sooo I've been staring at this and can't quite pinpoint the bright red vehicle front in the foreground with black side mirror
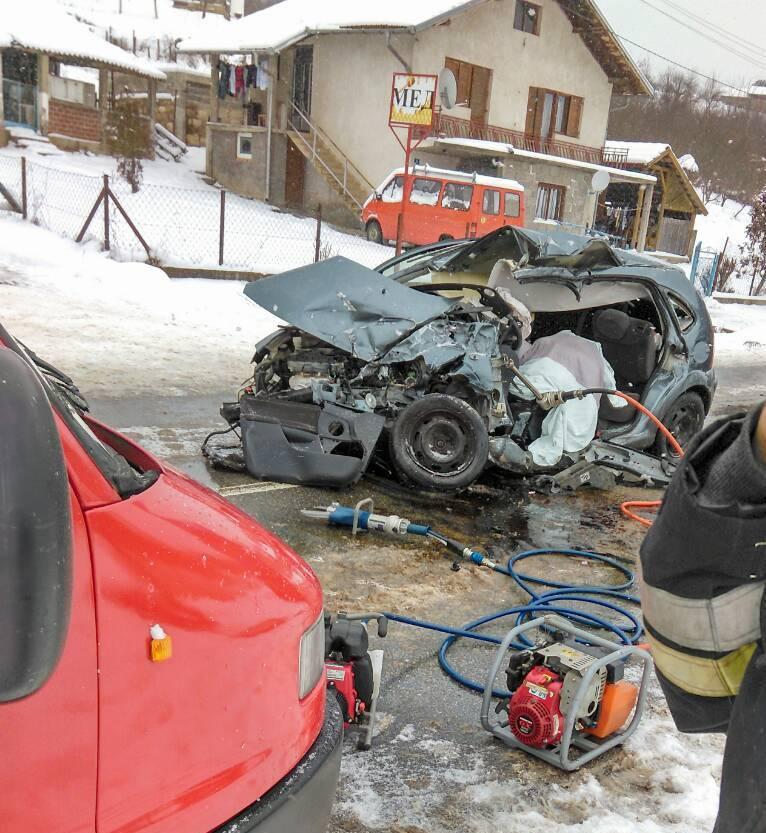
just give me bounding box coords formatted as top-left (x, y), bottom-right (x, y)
top-left (0, 326), bottom-right (343, 833)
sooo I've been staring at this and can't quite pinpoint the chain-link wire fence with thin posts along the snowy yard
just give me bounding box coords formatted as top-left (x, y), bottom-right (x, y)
top-left (0, 157), bottom-right (393, 274)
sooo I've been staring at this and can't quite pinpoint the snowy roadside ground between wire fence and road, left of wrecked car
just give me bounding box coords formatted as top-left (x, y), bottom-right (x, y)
top-left (0, 217), bottom-right (279, 397)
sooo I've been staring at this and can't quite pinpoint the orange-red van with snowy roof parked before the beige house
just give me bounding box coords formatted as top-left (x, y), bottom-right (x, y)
top-left (362, 165), bottom-right (525, 246)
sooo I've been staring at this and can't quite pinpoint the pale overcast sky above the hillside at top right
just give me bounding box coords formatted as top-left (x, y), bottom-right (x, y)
top-left (598, 0), bottom-right (766, 86)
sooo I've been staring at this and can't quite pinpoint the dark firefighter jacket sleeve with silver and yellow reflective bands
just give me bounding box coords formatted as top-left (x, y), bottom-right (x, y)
top-left (641, 419), bottom-right (766, 731)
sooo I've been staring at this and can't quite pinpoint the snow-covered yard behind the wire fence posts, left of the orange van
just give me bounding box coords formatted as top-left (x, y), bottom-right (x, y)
top-left (0, 141), bottom-right (394, 274)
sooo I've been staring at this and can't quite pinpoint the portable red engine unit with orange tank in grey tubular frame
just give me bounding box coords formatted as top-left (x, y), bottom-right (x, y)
top-left (481, 615), bottom-right (652, 771)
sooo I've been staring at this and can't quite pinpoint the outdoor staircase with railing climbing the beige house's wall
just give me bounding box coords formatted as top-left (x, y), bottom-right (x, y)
top-left (287, 101), bottom-right (375, 214)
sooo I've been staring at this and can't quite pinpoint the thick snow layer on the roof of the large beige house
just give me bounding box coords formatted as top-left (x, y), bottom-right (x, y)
top-left (179, 0), bottom-right (475, 52)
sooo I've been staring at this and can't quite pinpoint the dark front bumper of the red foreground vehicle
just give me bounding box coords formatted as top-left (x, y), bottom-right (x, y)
top-left (213, 697), bottom-right (343, 833)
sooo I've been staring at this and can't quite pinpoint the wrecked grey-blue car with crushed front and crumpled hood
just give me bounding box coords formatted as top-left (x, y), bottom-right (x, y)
top-left (205, 227), bottom-right (716, 491)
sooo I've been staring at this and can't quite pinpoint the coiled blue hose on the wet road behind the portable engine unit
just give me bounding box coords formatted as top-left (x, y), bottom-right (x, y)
top-left (385, 549), bottom-right (643, 697)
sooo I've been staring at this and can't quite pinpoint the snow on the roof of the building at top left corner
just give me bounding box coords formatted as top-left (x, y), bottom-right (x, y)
top-left (0, 0), bottom-right (165, 79)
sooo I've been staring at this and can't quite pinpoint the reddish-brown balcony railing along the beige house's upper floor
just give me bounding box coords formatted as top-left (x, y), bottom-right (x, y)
top-left (431, 113), bottom-right (628, 168)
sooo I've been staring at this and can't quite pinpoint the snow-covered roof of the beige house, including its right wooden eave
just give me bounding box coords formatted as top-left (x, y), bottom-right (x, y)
top-left (179, 0), bottom-right (652, 95)
